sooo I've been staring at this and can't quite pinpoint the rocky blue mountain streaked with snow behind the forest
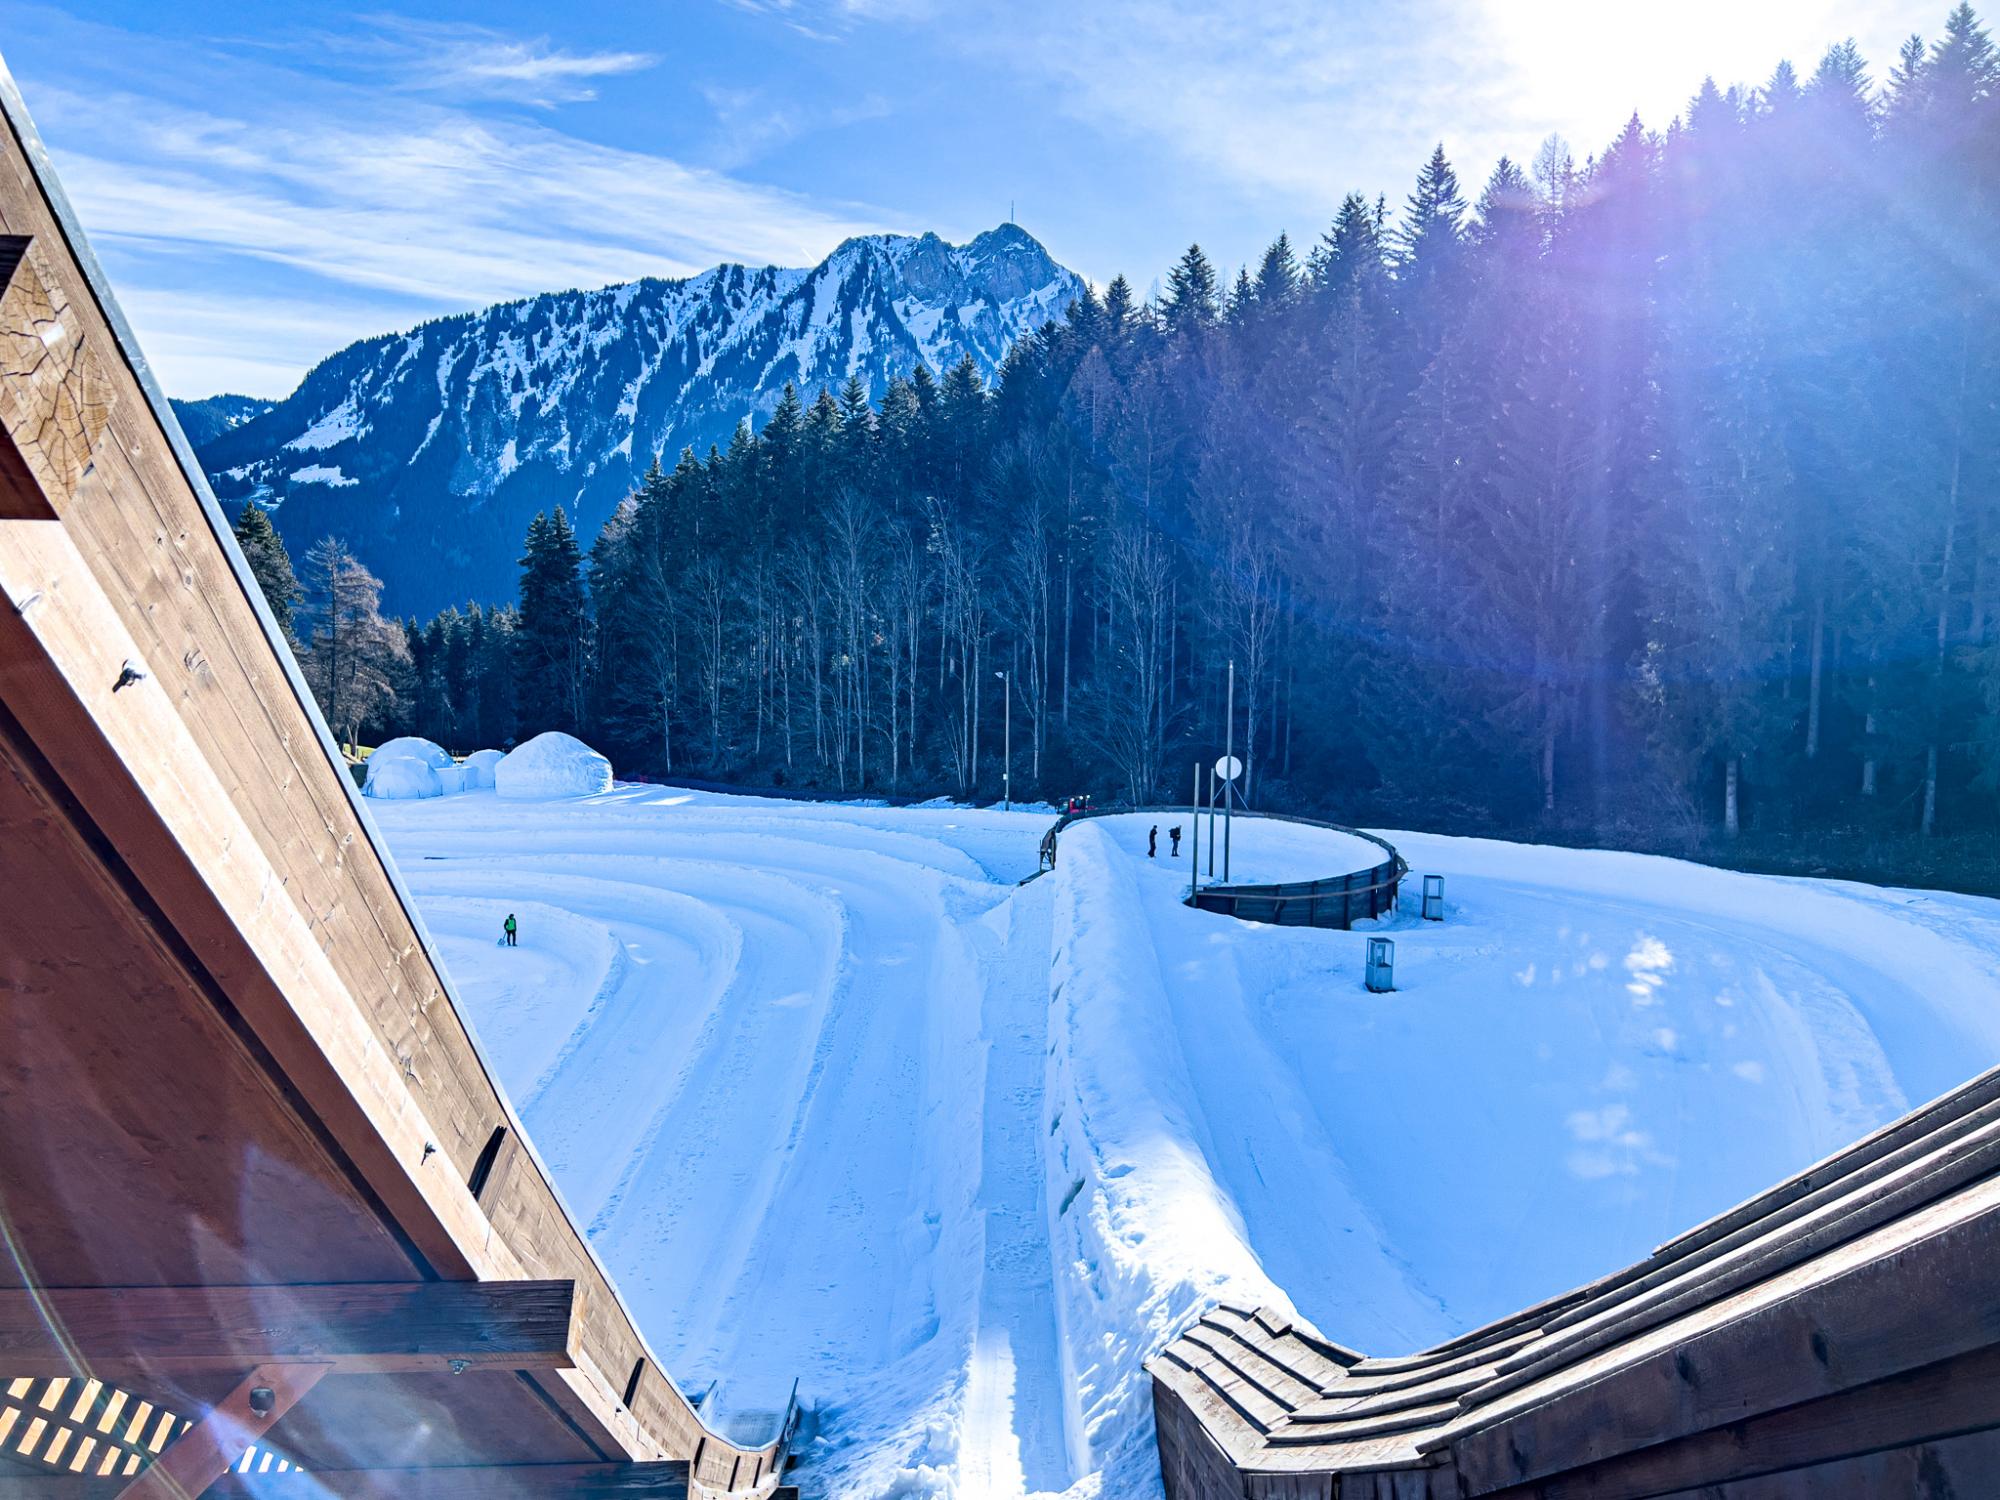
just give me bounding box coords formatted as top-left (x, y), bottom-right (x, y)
top-left (190, 224), bottom-right (1082, 614)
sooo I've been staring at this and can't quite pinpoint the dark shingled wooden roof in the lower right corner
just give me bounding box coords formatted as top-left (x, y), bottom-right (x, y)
top-left (1148, 1070), bottom-right (2000, 1500)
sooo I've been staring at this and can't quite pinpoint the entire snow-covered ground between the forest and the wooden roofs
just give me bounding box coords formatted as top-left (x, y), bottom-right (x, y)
top-left (364, 786), bottom-right (2000, 1496)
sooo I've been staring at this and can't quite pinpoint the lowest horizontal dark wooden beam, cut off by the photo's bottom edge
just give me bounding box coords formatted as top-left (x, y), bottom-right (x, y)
top-left (0, 1460), bottom-right (692, 1500)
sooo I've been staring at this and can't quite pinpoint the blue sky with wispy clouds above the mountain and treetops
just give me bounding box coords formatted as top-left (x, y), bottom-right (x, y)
top-left (0, 0), bottom-right (1948, 396)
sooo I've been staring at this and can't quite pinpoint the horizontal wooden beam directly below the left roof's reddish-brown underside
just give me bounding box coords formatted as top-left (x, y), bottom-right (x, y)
top-left (0, 1282), bottom-right (576, 1378)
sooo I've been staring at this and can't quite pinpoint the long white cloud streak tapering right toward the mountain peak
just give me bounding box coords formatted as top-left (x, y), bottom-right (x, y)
top-left (38, 90), bottom-right (880, 306)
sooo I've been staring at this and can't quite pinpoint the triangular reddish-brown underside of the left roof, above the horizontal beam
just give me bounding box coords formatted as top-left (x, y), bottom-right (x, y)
top-left (0, 716), bottom-right (420, 1286)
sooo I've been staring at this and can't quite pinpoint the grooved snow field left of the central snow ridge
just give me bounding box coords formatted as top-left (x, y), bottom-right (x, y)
top-left (368, 788), bottom-right (1072, 1494)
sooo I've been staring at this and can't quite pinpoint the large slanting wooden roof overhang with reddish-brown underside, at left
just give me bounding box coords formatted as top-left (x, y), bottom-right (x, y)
top-left (0, 50), bottom-right (784, 1496)
